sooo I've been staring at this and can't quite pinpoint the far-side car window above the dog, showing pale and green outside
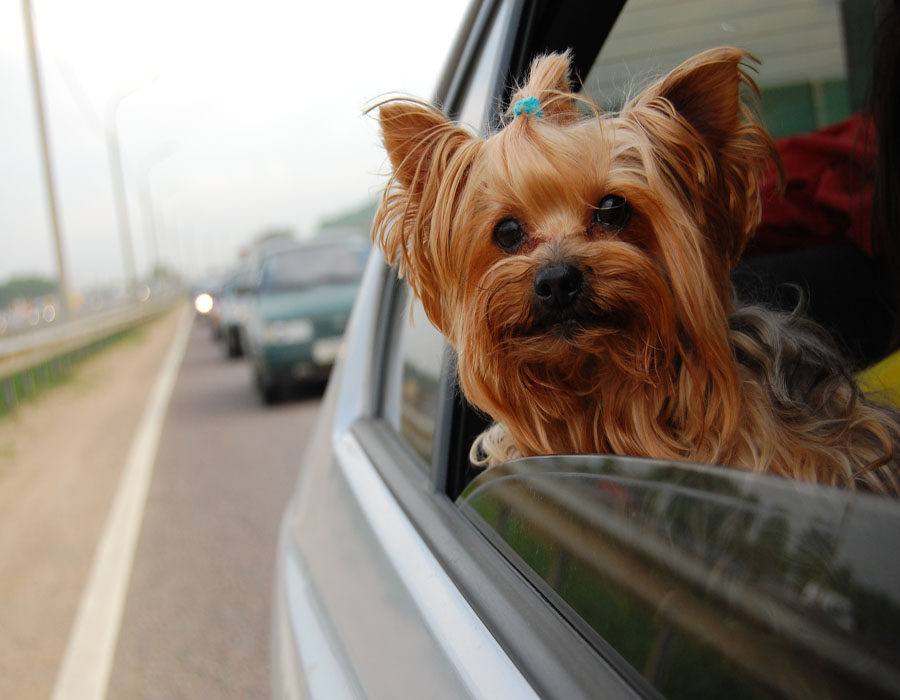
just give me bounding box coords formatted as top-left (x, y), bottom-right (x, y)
top-left (584, 0), bottom-right (856, 137)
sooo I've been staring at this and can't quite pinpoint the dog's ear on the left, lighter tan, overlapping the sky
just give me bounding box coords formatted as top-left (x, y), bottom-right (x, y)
top-left (373, 100), bottom-right (480, 333)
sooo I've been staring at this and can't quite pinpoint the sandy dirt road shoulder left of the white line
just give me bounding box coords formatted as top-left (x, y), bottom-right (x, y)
top-left (0, 308), bottom-right (187, 698)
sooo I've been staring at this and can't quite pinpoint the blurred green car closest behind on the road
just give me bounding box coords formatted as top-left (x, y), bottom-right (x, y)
top-left (246, 241), bottom-right (369, 403)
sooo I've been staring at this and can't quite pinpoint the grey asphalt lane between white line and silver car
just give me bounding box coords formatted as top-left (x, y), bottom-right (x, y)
top-left (108, 318), bottom-right (319, 698)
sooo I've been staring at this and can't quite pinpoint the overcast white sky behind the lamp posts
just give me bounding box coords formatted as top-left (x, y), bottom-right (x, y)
top-left (0, 0), bottom-right (469, 289)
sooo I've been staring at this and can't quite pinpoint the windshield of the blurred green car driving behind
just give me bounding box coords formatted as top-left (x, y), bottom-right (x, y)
top-left (259, 246), bottom-right (367, 291)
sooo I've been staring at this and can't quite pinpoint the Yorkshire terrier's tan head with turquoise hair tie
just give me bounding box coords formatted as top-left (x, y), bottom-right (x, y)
top-left (375, 49), bottom-right (772, 453)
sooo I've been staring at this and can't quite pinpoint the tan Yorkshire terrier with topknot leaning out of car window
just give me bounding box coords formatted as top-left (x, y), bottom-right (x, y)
top-left (373, 48), bottom-right (900, 495)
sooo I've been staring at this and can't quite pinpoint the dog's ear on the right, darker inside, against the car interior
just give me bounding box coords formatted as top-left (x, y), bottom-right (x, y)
top-left (623, 48), bottom-right (777, 272)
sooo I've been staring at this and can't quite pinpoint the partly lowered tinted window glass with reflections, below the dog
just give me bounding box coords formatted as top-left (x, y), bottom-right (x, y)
top-left (460, 456), bottom-right (900, 698)
